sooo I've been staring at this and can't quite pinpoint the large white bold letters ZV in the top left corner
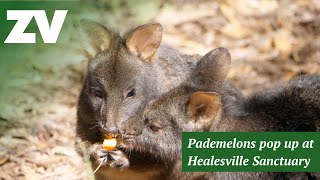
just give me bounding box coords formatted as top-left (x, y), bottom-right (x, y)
top-left (4, 10), bottom-right (68, 43)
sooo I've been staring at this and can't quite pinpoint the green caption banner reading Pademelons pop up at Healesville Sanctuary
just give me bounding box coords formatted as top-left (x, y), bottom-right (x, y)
top-left (182, 132), bottom-right (320, 172)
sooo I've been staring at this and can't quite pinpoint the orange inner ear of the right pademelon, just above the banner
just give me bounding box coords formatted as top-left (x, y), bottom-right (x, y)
top-left (187, 91), bottom-right (221, 122)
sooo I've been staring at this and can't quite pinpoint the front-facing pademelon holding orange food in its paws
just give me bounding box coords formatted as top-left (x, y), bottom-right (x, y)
top-left (76, 20), bottom-right (199, 179)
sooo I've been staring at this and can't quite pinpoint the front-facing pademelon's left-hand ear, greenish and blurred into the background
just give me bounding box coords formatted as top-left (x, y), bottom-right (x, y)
top-left (79, 19), bottom-right (111, 57)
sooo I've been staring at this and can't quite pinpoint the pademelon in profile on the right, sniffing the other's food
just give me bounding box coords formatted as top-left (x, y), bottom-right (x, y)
top-left (123, 48), bottom-right (320, 179)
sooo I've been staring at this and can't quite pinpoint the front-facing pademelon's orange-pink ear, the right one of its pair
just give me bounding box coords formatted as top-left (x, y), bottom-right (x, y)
top-left (126, 23), bottom-right (162, 62)
